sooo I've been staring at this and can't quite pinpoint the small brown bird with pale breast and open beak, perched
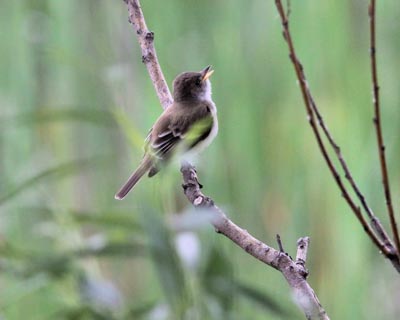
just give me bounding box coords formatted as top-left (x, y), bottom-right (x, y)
top-left (115, 66), bottom-right (218, 200)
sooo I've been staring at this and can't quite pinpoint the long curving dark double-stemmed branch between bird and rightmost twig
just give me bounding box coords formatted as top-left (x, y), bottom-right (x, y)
top-left (275, 0), bottom-right (400, 272)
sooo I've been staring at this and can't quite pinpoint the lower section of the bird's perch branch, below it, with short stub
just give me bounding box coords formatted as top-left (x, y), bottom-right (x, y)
top-left (181, 163), bottom-right (329, 320)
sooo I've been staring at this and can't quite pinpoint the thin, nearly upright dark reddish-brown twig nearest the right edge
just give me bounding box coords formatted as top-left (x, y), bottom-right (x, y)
top-left (368, 0), bottom-right (400, 258)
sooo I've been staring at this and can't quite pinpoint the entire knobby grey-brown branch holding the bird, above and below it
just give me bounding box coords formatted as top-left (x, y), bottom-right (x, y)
top-left (124, 0), bottom-right (329, 320)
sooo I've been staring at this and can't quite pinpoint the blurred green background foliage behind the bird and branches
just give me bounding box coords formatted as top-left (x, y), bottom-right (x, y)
top-left (0, 0), bottom-right (400, 320)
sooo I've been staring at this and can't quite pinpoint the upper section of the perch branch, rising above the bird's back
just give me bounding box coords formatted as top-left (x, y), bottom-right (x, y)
top-left (124, 0), bottom-right (173, 109)
